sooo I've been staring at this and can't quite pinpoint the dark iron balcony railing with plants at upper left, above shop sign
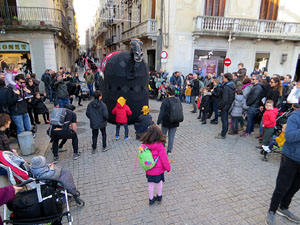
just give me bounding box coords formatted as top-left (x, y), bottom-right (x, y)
top-left (0, 6), bottom-right (70, 33)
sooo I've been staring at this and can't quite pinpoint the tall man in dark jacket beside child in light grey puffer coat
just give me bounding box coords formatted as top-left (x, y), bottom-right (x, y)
top-left (215, 73), bottom-right (236, 139)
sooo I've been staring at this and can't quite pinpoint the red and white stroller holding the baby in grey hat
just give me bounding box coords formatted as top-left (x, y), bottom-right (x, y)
top-left (0, 151), bottom-right (85, 207)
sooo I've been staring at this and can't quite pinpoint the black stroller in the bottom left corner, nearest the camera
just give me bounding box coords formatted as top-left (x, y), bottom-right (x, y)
top-left (3, 178), bottom-right (73, 225)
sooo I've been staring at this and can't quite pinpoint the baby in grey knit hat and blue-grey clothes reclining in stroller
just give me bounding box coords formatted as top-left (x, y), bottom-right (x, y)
top-left (30, 156), bottom-right (84, 206)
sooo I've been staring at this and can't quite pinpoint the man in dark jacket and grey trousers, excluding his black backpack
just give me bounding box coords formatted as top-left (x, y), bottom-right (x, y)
top-left (157, 85), bottom-right (180, 155)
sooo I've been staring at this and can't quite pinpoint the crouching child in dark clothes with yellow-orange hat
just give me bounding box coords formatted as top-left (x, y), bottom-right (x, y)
top-left (134, 105), bottom-right (153, 140)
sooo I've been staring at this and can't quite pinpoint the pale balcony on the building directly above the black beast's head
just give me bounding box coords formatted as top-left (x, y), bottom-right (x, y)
top-left (122, 19), bottom-right (157, 41)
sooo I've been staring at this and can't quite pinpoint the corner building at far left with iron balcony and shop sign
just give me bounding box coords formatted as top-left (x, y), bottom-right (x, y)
top-left (0, 0), bottom-right (78, 77)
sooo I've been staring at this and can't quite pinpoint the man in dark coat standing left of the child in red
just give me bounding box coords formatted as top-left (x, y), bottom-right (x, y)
top-left (86, 90), bottom-right (109, 154)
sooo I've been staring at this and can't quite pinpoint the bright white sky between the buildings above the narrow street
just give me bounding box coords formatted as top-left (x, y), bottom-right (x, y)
top-left (74, 0), bottom-right (100, 45)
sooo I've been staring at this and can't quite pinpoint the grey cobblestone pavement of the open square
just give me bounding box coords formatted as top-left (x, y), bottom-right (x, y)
top-left (48, 101), bottom-right (300, 225)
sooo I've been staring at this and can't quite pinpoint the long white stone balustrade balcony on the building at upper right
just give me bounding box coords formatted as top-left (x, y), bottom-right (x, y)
top-left (193, 16), bottom-right (300, 41)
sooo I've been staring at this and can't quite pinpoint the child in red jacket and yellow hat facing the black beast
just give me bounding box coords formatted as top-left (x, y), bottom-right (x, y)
top-left (112, 96), bottom-right (132, 140)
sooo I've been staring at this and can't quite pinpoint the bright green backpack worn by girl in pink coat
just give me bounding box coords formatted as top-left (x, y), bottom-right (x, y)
top-left (135, 144), bottom-right (159, 171)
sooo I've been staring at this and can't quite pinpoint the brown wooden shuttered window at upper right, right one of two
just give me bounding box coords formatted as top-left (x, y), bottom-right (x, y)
top-left (259, 0), bottom-right (279, 20)
